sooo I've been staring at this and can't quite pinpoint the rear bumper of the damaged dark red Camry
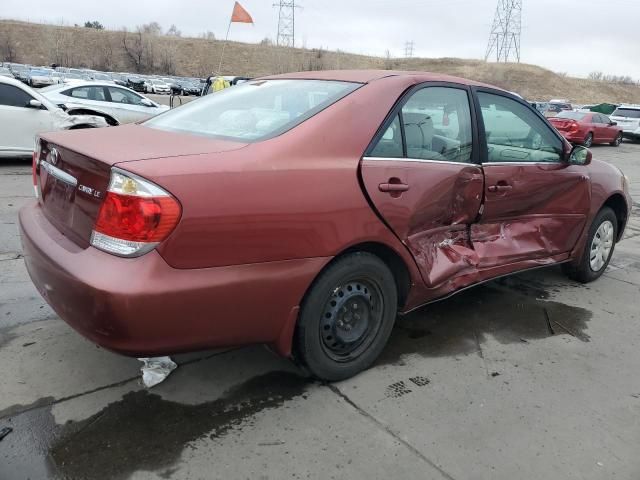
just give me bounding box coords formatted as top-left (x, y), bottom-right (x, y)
top-left (20, 201), bottom-right (329, 357)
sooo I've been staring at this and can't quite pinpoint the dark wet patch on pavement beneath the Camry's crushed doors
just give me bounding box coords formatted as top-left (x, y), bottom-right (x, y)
top-left (377, 277), bottom-right (592, 365)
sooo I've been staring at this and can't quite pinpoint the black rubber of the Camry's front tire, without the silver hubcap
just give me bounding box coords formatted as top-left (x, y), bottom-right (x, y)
top-left (562, 207), bottom-right (618, 283)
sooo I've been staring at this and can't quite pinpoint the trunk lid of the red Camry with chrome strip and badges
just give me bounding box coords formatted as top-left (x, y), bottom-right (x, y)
top-left (35, 125), bottom-right (246, 248)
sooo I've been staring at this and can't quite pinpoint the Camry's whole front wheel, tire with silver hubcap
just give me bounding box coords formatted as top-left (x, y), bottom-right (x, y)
top-left (563, 207), bottom-right (618, 283)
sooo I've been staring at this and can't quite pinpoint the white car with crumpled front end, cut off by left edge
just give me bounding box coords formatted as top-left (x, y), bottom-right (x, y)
top-left (0, 77), bottom-right (107, 158)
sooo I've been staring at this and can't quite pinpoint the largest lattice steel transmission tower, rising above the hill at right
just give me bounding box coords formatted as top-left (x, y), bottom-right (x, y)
top-left (484, 0), bottom-right (522, 63)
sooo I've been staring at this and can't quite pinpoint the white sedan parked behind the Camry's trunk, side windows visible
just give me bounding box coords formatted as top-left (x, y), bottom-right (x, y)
top-left (40, 81), bottom-right (169, 125)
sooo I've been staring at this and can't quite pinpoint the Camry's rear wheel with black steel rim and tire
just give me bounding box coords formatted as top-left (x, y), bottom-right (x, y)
top-left (294, 252), bottom-right (398, 381)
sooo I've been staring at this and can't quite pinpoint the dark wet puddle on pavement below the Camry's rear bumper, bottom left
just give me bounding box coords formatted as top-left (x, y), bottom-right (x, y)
top-left (0, 371), bottom-right (310, 480)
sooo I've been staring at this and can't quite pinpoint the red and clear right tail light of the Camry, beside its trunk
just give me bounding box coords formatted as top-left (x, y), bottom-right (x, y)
top-left (91, 168), bottom-right (182, 257)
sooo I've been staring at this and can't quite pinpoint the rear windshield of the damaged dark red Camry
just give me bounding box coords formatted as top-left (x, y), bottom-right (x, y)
top-left (144, 80), bottom-right (360, 142)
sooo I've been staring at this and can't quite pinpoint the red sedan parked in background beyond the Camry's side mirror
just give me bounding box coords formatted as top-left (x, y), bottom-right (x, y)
top-left (549, 112), bottom-right (622, 148)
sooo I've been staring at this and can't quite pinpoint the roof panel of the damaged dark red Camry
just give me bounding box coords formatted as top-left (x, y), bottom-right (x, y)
top-left (261, 70), bottom-right (496, 88)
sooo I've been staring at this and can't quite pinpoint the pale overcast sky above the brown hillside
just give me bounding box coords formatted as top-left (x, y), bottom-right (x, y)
top-left (5, 0), bottom-right (640, 79)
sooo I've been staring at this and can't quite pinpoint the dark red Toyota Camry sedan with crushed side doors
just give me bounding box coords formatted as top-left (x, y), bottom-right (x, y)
top-left (20, 71), bottom-right (631, 380)
